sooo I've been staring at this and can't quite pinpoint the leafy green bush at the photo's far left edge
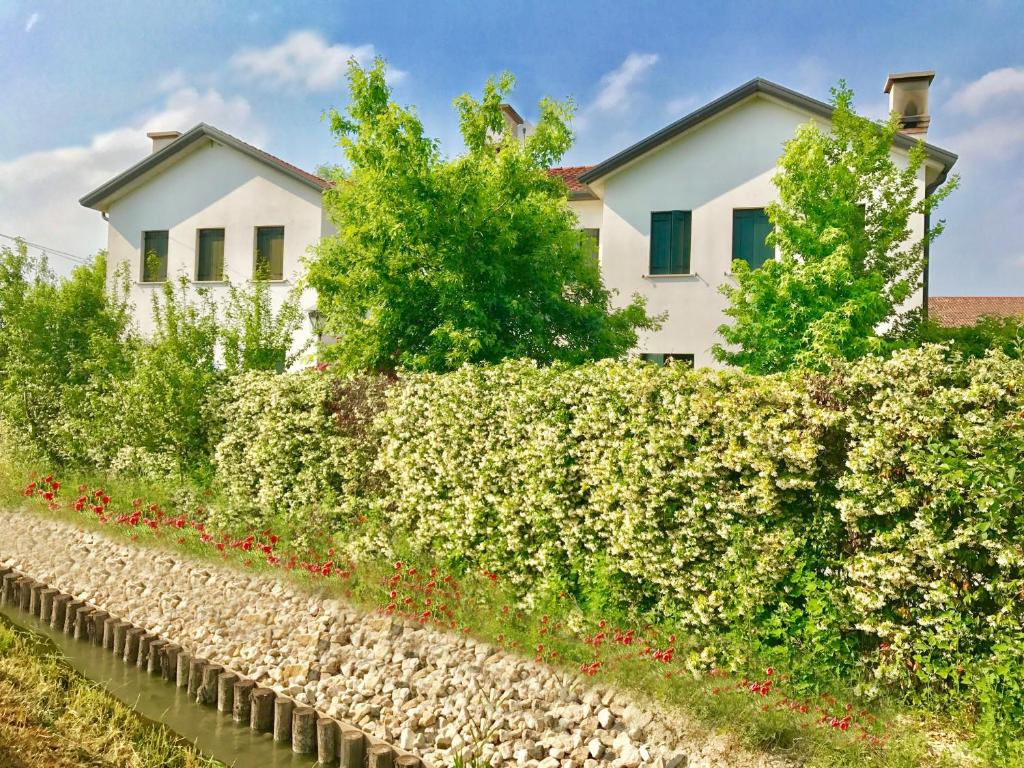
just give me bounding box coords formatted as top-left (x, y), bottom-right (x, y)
top-left (0, 245), bottom-right (131, 462)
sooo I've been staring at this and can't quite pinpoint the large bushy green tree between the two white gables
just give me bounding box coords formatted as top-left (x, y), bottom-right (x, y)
top-left (308, 60), bottom-right (653, 371)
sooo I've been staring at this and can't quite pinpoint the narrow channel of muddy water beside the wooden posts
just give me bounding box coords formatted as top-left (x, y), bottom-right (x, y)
top-left (0, 606), bottom-right (318, 768)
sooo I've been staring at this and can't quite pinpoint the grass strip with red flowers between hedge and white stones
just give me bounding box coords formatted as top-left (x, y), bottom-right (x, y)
top-left (0, 456), bottom-right (978, 768)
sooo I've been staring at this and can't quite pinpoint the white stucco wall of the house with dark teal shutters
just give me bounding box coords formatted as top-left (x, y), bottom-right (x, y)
top-left (570, 95), bottom-right (924, 366)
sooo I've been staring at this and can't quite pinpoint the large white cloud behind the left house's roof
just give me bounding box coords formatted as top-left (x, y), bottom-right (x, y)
top-left (0, 88), bottom-right (265, 268)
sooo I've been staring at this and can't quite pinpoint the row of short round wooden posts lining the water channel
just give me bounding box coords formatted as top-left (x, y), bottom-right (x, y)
top-left (0, 567), bottom-right (421, 768)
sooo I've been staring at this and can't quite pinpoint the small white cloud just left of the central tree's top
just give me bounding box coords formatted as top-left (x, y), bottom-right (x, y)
top-left (231, 31), bottom-right (406, 91)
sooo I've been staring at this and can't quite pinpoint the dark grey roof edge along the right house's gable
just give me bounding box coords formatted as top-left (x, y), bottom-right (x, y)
top-left (579, 78), bottom-right (956, 185)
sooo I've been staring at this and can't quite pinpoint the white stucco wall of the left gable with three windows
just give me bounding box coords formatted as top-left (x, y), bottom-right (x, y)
top-left (108, 141), bottom-right (332, 364)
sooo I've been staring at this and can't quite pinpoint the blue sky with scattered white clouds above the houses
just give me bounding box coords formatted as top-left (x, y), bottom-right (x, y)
top-left (0, 0), bottom-right (1024, 295)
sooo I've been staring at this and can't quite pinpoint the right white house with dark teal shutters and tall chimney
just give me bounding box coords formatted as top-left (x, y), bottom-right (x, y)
top-left (551, 72), bottom-right (956, 366)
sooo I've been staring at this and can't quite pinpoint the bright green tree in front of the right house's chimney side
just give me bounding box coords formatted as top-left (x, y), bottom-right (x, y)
top-left (714, 81), bottom-right (956, 373)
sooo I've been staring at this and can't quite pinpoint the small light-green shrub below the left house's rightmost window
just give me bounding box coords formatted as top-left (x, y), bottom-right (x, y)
top-left (220, 280), bottom-right (310, 374)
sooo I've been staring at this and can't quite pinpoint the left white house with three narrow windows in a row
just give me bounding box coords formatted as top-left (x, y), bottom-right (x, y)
top-left (80, 124), bottom-right (334, 358)
